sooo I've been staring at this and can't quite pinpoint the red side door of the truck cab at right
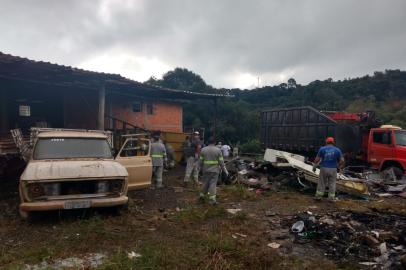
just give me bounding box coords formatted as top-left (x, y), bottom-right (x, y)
top-left (369, 130), bottom-right (394, 168)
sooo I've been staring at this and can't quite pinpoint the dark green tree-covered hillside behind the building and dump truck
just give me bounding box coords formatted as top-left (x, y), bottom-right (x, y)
top-left (147, 68), bottom-right (406, 142)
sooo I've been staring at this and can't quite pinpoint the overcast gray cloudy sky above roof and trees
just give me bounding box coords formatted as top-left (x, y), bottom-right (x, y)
top-left (0, 0), bottom-right (406, 88)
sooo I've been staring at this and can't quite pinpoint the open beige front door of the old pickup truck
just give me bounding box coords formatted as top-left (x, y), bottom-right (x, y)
top-left (116, 138), bottom-right (152, 190)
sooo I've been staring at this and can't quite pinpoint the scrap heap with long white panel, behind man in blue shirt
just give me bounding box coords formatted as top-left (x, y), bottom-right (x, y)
top-left (225, 149), bottom-right (406, 198)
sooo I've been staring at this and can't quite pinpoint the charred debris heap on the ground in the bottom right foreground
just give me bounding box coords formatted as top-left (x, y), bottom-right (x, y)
top-left (280, 211), bottom-right (406, 269)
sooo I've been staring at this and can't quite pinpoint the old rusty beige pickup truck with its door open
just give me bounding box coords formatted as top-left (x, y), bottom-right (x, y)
top-left (19, 130), bottom-right (152, 218)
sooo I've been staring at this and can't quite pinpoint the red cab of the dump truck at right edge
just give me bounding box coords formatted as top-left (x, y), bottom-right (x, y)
top-left (367, 125), bottom-right (406, 177)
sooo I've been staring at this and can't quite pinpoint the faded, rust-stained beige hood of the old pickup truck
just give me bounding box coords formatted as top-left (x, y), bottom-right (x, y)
top-left (21, 160), bottom-right (128, 180)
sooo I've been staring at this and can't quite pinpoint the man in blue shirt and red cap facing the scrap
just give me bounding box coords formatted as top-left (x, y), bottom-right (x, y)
top-left (313, 137), bottom-right (344, 200)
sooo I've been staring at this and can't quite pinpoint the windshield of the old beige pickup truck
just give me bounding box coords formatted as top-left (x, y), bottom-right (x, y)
top-left (34, 138), bottom-right (113, 159)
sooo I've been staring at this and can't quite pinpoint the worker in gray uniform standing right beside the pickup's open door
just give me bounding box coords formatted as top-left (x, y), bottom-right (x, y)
top-left (151, 134), bottom-right (167, 188)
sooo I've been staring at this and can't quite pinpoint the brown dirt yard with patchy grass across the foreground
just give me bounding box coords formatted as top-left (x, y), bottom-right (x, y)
top-left (0, 167), bottom-right (406, 269)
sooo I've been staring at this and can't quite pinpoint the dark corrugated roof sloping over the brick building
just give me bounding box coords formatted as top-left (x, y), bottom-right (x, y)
top-left (0, 52), bottom-right (232, 99)
